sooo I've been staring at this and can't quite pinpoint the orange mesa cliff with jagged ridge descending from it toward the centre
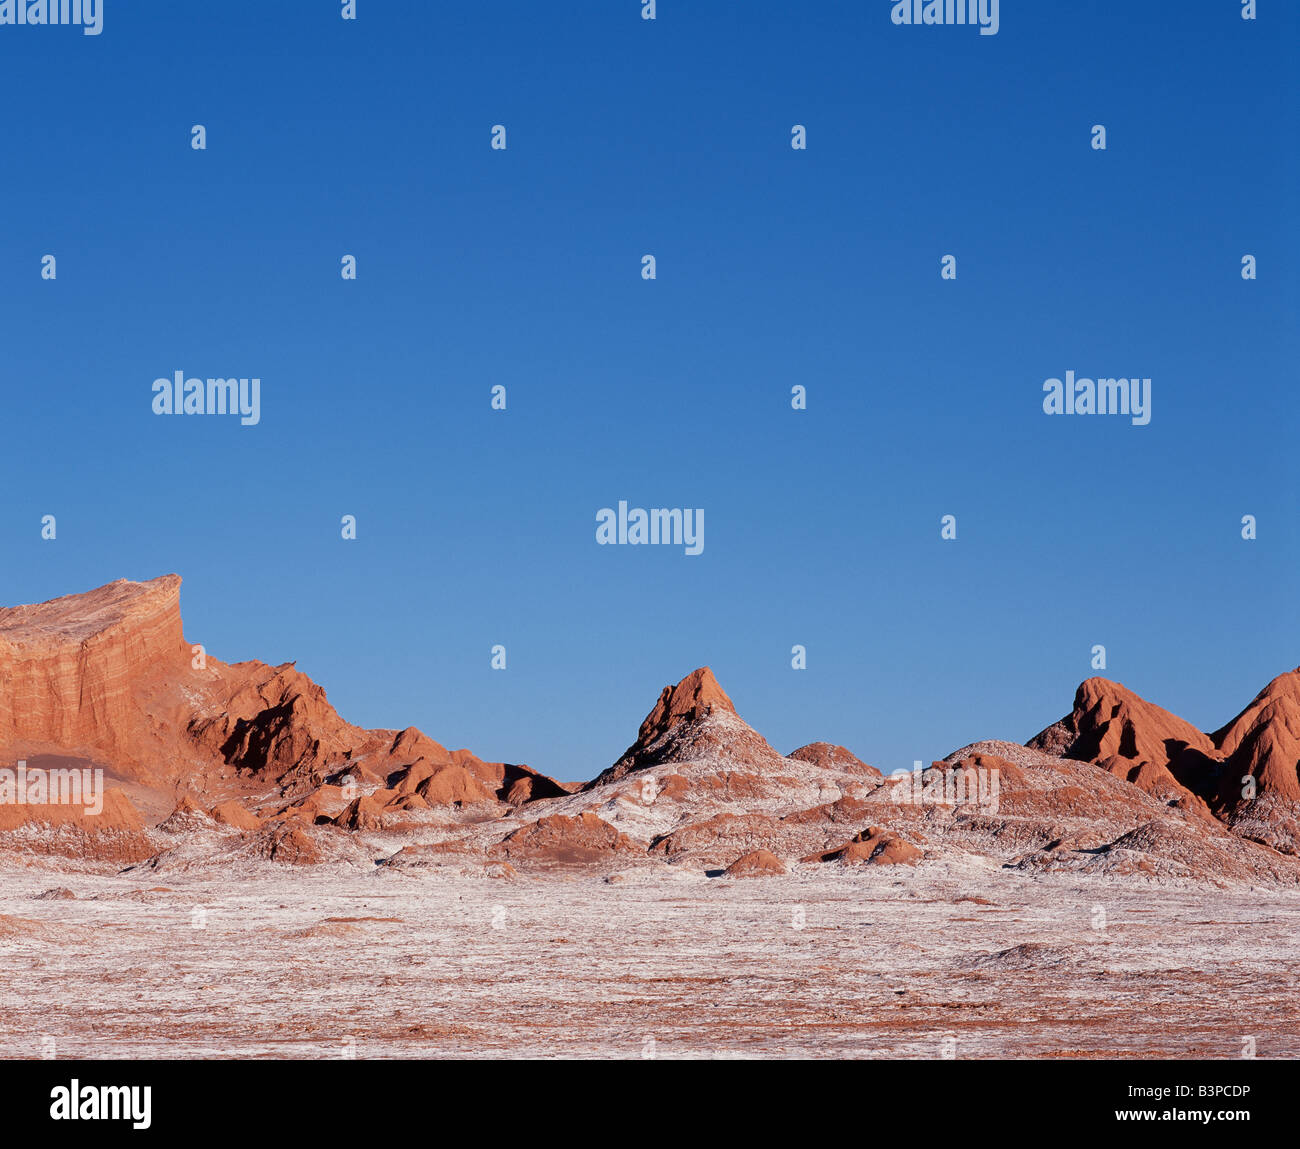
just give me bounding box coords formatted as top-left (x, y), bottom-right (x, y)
top-left (0, 575), bottom-right (564, 852)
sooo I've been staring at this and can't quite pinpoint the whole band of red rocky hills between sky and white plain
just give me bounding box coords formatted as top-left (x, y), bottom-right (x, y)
top-left (0, 575), bottom-right (1300, 885)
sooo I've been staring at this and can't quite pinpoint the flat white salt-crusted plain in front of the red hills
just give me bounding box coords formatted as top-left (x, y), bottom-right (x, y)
top-left (0, 859), bottom-right (1300, 1059)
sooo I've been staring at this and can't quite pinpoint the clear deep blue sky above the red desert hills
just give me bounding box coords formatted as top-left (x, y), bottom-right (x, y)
top-left (0, 0), bottom-right (1300, 779)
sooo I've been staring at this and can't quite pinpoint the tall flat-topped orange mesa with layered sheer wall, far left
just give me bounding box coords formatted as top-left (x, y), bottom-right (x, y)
top-left (0, 575), bottom-right (189, 760)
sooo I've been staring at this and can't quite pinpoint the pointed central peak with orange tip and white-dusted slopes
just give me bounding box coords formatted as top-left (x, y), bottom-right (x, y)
top-left (582, 667), bottom-right (783, 790)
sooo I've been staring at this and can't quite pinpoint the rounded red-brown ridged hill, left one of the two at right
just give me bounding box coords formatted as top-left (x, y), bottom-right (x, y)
top-left (1026, 678), bottom-right (1216, 766)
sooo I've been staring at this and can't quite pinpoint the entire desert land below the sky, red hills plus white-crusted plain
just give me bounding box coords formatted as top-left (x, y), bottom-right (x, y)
top-left (0, 575), bottom-right (1300, 1059)
